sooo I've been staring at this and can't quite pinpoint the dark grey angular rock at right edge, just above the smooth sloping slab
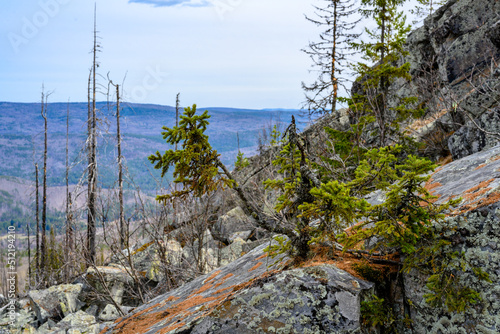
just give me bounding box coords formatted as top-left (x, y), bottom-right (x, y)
top-left (448, 108), bottom-right (500, 160)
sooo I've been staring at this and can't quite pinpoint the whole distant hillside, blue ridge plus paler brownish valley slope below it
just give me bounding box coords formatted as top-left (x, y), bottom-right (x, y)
top-left (0, 102), bottom-right (306, 234)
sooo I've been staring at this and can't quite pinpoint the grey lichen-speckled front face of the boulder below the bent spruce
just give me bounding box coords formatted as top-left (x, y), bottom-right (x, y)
top-left (191, 265), bottom-right (372, 334)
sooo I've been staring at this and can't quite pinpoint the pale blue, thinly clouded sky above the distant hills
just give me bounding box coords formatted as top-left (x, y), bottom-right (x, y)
top-left (0, 0), bottom-right (422, 109)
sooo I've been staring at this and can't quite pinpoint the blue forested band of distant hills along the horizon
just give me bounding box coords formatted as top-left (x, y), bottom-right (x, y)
top-left (0, 102), bottom-right (305, 192)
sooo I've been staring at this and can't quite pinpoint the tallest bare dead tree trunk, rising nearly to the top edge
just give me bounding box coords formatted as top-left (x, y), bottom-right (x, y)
top-left (86, 7), bottom-right (97, 265)
